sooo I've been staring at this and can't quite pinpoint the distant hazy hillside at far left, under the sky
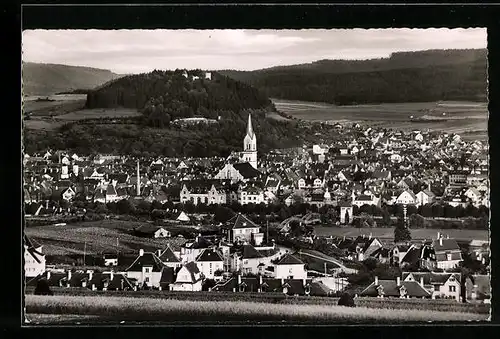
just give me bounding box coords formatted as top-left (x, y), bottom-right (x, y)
top-left (22, 62), bottom-right (121, 96)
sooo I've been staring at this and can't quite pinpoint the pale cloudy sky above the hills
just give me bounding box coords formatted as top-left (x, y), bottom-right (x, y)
top-left (22, 28), bottom-right (487, 74)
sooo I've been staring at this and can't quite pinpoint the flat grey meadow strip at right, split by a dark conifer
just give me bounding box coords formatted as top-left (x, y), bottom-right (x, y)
top-left (314, 226), bottom-right (489, 240)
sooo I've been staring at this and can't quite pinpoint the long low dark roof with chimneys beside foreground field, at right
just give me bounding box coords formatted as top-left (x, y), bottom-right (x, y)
top-left (360, 277), bottom-right (431, 299)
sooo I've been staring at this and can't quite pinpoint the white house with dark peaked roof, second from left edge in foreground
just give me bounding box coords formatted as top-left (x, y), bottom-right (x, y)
top-left (125, 249), bottom-right (165, 288)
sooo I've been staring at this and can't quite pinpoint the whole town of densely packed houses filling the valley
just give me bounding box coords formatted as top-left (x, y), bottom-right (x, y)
top-left (24, 115), bottom-right (491, 303)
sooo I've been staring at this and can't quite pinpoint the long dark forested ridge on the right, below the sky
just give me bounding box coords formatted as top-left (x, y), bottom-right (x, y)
top-left (220, 49), bottom-right (488, 105)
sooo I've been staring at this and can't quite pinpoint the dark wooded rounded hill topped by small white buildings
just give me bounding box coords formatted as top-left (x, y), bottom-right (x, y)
top-left (86, 70), bottom-right (273, 127)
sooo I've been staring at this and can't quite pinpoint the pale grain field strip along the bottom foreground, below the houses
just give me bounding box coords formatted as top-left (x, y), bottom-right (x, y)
top-left (25, 295), bottom-right (489, 324)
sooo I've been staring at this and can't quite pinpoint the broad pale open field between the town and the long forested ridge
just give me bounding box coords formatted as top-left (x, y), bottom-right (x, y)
top-left (273, 99), bottom-right (488, 139)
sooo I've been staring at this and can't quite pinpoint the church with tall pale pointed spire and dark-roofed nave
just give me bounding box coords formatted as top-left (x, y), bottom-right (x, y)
top-left (215, 114), bottom-right (261, 182)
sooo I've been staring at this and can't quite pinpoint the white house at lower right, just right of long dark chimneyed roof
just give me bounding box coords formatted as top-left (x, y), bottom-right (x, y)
top-left (403, 272), bottom-right (461, 301)
